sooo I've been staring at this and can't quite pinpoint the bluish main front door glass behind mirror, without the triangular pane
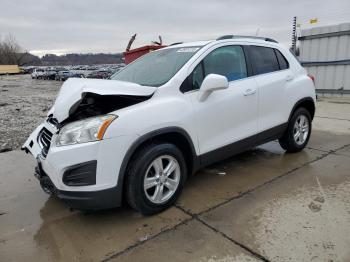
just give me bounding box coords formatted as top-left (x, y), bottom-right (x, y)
top-left (203, 46), bottom-right (247, 81)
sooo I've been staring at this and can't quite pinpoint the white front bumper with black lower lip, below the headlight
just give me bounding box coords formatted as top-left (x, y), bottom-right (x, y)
top-left (23, 123), bottom-right (136, 210)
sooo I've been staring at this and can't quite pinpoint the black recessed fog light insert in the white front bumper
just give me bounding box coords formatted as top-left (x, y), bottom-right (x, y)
top-left (62, 160), bottom-right (97, 186)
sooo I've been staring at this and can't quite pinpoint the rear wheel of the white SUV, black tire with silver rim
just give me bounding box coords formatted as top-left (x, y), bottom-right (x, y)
top-left (279, 107), bottom-right (312, 153)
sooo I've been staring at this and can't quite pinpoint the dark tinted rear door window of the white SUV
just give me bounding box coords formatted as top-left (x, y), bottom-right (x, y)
top-left (249, 46), bottom-right (279, 75)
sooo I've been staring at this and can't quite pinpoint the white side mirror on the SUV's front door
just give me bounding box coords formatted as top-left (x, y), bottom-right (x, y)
top-left (198, 74), bottom-right (228, 102)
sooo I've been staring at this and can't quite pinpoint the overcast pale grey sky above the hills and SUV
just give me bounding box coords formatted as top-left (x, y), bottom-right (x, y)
top-left (0, 0), bottom-right (350, 56)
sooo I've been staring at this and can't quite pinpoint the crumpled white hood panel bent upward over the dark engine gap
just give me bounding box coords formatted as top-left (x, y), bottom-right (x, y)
top-left (48, 78), bottom-right (157, 122)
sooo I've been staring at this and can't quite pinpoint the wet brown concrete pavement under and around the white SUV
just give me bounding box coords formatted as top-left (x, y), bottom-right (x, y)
top-left (0, 99), bottom-right (350, 261)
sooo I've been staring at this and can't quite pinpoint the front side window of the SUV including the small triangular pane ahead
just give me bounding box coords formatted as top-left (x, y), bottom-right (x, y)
top-left (180, 46), bottom-right (247, 92)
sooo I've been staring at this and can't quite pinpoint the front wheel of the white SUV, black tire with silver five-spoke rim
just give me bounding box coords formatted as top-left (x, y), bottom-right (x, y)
top-left (126, 143), bottom-right (187, 215)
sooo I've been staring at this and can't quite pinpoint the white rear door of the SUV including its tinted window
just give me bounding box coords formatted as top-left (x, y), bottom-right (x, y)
top-left (249, 46), bottom-right (293, 133)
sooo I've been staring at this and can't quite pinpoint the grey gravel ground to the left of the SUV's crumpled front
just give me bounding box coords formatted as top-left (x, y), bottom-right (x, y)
top-left (0, 75), bottom-right (62, 152)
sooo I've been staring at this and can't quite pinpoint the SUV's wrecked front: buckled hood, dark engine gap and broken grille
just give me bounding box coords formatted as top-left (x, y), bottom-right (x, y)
top-left (22, 76), bottom-right (156, 158)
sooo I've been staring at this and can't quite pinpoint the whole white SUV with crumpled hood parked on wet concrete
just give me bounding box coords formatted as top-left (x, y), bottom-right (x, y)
top-left (23, 36), bottom-right (315, 214)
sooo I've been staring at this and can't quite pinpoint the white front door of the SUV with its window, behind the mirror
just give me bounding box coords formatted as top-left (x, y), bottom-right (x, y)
top-left (185, 45), bottom-right (258, 163)
